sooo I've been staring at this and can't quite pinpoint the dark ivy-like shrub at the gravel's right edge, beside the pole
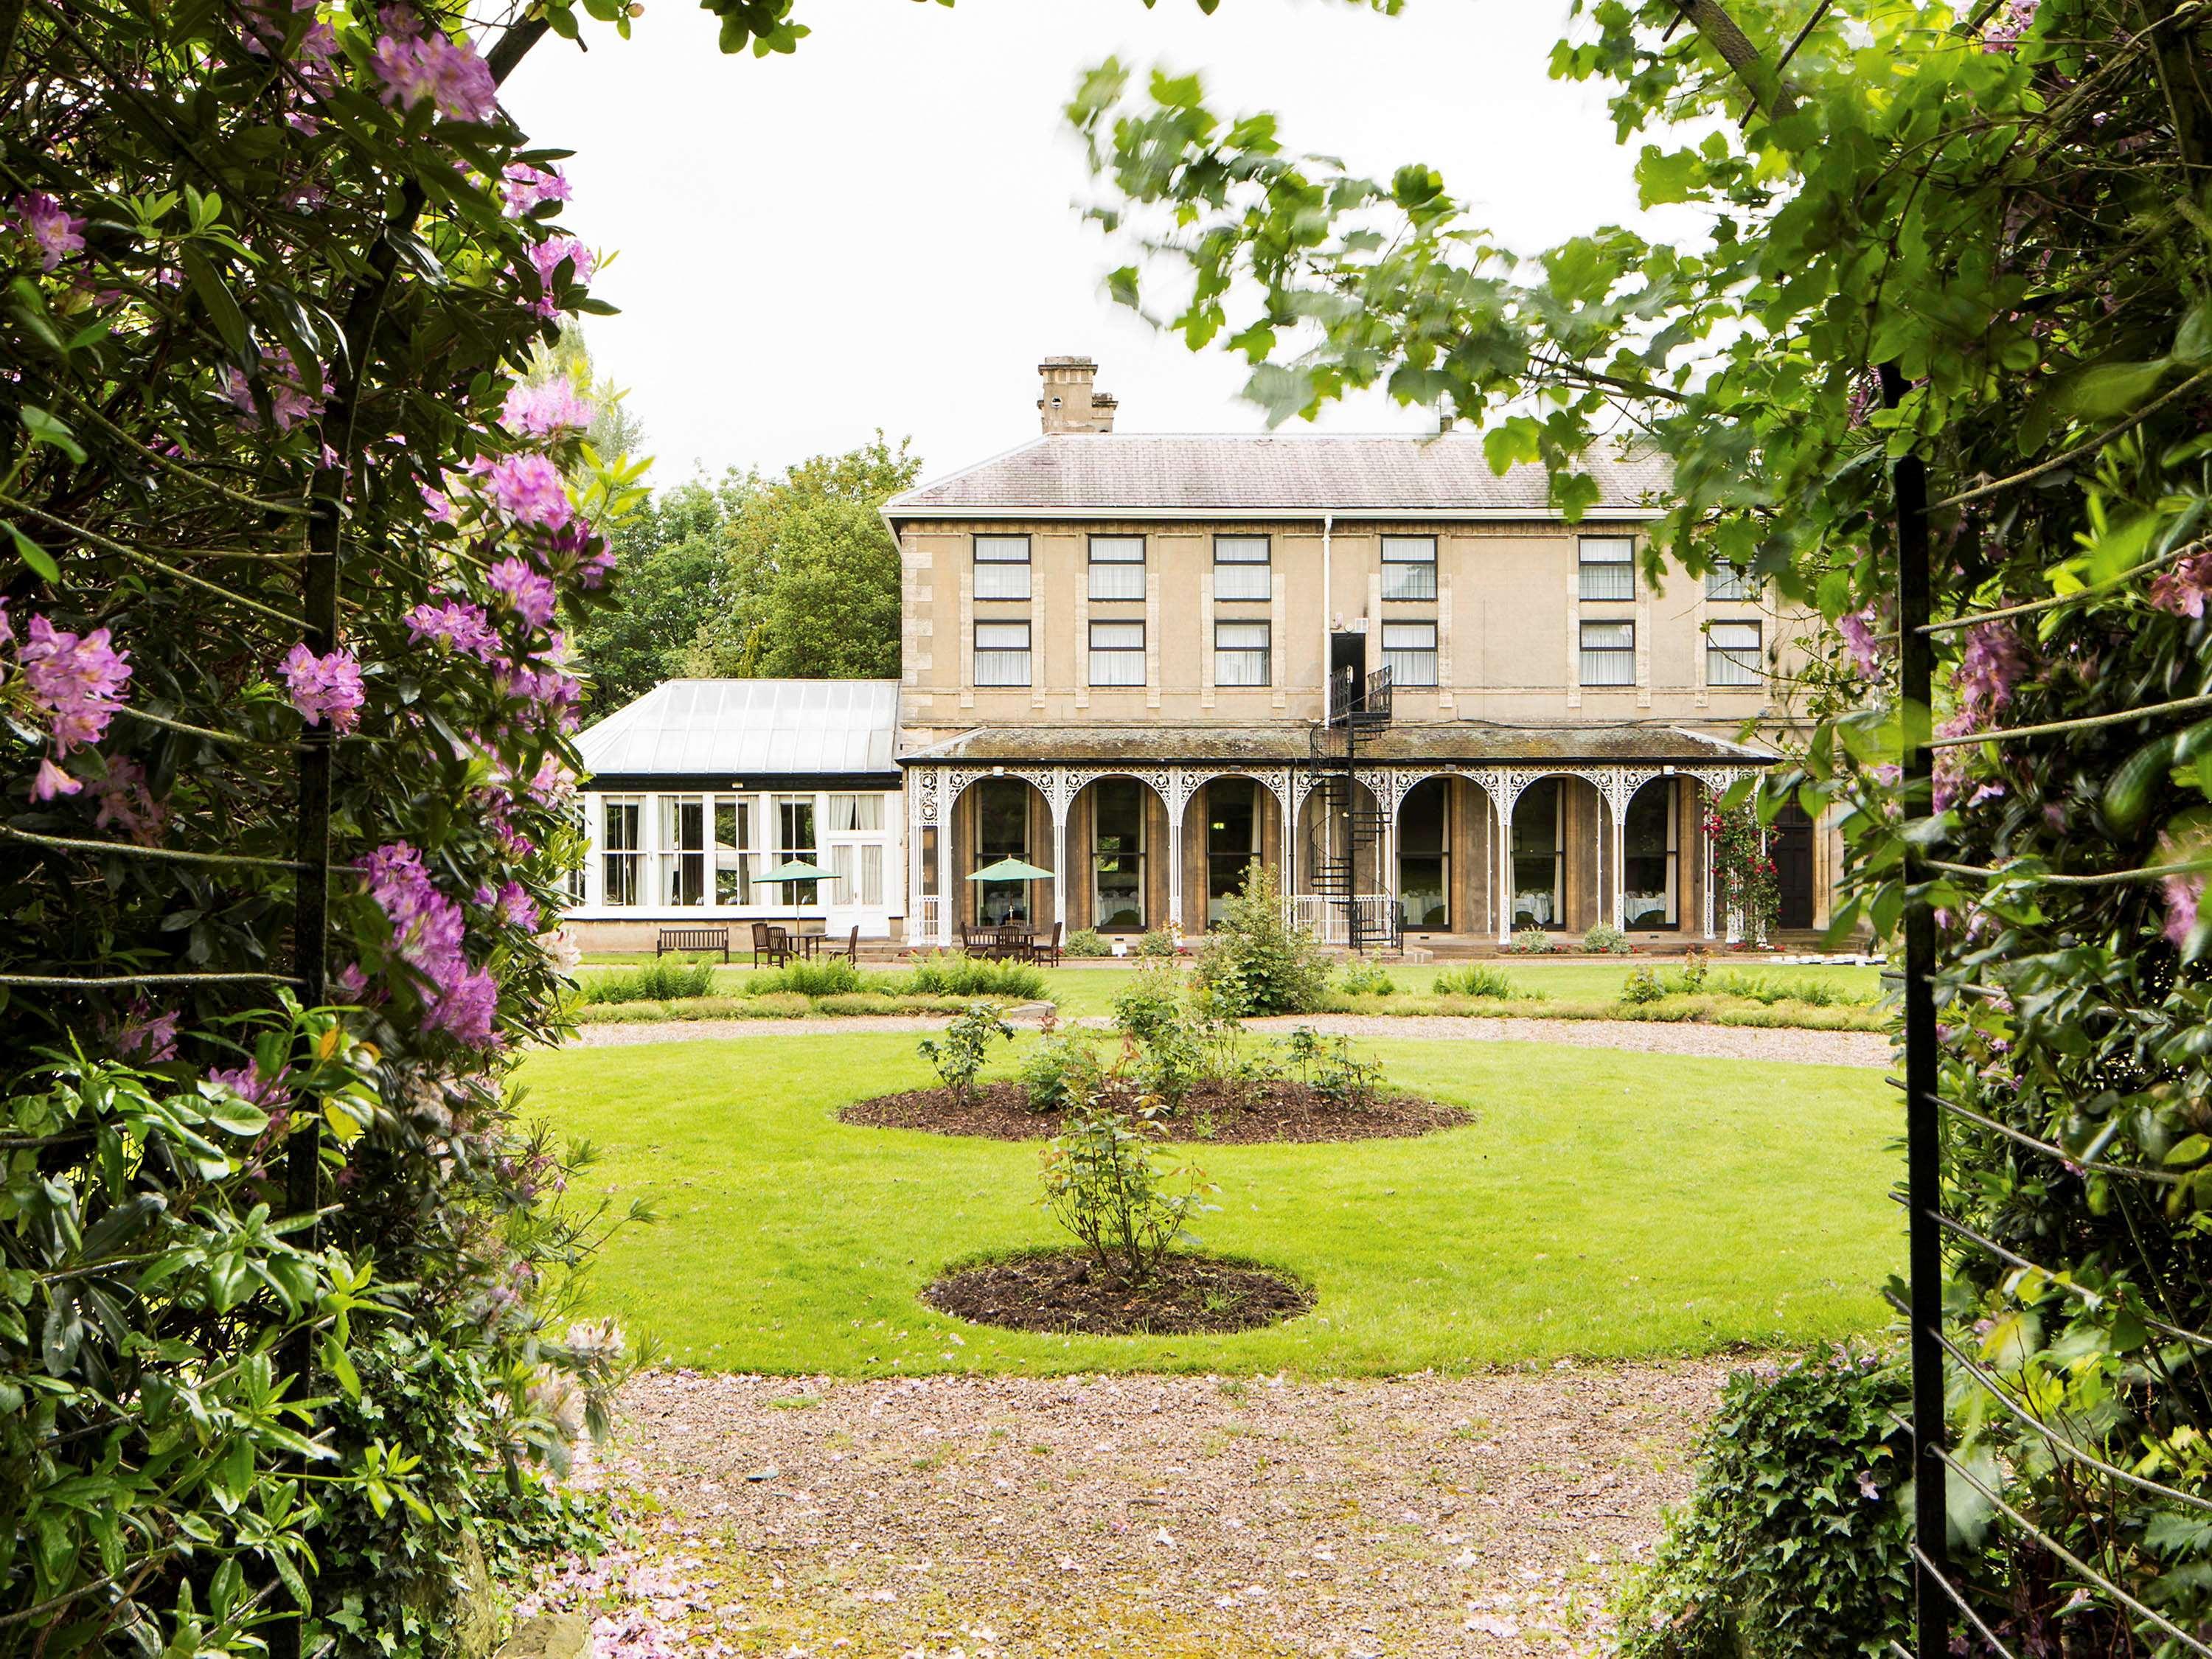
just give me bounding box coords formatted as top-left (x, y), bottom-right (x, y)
top-left (1619, 1352), bottom-right (1913, 1659)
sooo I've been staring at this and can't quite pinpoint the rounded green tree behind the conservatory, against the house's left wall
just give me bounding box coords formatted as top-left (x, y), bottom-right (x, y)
top-left (686, 431), bottom-right (922, 679)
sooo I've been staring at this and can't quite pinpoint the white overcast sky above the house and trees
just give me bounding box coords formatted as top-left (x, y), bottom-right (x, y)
top-left (504, 0), bottom-right (1635, 484)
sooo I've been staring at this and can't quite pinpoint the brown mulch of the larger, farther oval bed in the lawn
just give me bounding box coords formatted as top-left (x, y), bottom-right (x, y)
top-left (838, 1082), bottom-right (1475, 1144)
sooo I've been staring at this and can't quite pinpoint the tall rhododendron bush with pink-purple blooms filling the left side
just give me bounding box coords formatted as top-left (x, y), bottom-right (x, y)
top-left (0, 0), bottom-right (787, 1655)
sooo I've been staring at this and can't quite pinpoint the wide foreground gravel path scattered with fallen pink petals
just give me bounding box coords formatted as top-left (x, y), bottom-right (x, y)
top-left (588, 1363), bottom-right (1723, 1659)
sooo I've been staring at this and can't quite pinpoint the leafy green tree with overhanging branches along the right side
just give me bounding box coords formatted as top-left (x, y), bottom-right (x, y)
top-left (1071, 0), bottom-right (2212, 1652)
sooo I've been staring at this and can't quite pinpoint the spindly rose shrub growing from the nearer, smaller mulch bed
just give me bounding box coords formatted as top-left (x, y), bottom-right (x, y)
top-left (1040, 1104), bottom-right (1219, 1287)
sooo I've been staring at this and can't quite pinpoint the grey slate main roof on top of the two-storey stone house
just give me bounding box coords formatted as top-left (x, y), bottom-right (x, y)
top-left (883, 431), bottom-right (1668, 522)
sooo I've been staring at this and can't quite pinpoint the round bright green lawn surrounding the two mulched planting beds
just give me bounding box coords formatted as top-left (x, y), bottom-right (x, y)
top-left (522, 1033), bottom-right (1902, 1376)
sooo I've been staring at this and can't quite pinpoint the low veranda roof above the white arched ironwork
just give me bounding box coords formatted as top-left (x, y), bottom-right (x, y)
top-left (898, 721), bottom-right (1781, 765)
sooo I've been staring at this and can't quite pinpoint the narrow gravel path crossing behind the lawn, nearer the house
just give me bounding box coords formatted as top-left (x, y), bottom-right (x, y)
top-left (575, 1013), bottom-right (1889, 1071)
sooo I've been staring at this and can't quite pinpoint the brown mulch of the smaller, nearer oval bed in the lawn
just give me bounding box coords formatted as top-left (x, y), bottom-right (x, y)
top-left (922, 1250), bottom-right (1314, 1336)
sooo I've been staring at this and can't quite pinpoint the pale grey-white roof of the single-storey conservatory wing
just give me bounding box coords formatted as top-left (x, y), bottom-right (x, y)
top-left (575, 679), bottom-right (898, 779)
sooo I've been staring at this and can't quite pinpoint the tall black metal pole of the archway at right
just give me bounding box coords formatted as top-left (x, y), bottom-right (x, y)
top-left (1880, 363), bottom-right (1951, 1659)
